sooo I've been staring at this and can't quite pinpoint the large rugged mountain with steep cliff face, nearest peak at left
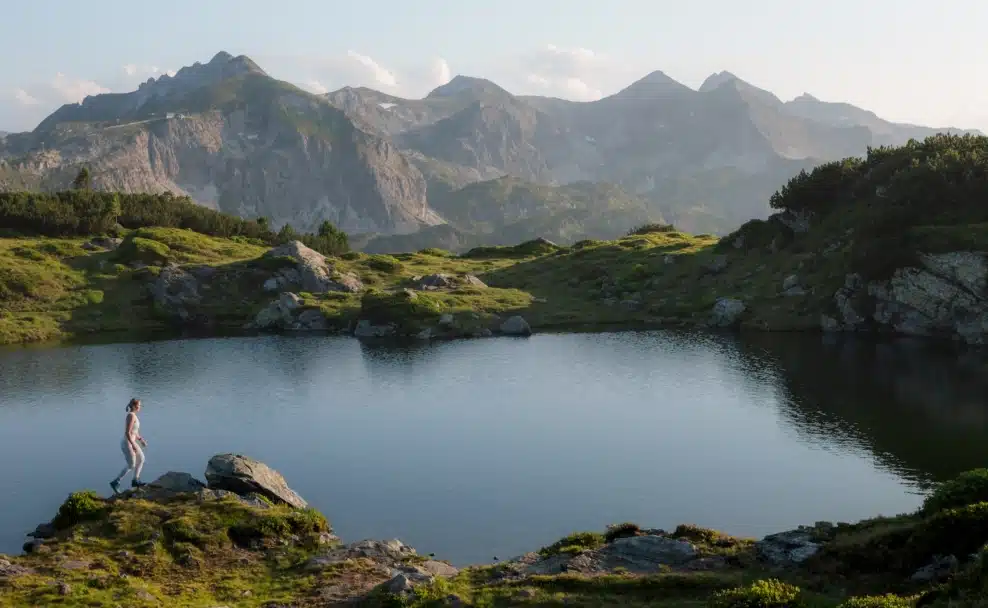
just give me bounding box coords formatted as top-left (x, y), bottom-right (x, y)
top-left (0, 54), bottom-right (442, 234)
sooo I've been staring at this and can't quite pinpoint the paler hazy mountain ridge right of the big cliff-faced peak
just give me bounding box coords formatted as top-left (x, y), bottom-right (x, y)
top-left (326, 66), bottom-right (976, 238)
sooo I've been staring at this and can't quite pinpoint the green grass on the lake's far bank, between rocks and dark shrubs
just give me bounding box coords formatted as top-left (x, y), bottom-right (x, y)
top-left (0, 192), bottom-right (988, 343)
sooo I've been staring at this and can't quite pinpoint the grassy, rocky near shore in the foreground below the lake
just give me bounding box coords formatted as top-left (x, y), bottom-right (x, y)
top-left (0, 470), bottom-right (988, 608)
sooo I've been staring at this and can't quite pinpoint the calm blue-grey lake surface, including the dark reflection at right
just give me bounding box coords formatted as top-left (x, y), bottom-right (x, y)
top-left (0, 332), bottom-right (988, 564)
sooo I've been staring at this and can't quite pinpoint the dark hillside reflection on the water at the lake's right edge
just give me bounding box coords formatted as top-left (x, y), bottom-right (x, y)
top-left (738, 334), bottom-right (988, 489)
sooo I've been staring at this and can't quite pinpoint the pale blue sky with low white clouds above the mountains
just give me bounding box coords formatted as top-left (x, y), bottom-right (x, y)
top-left (0, 0), bottom-right (988, 132)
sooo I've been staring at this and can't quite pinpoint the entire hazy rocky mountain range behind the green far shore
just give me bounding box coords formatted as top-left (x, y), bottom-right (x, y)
top-left (0, 52), bottom-right (965, 251)
